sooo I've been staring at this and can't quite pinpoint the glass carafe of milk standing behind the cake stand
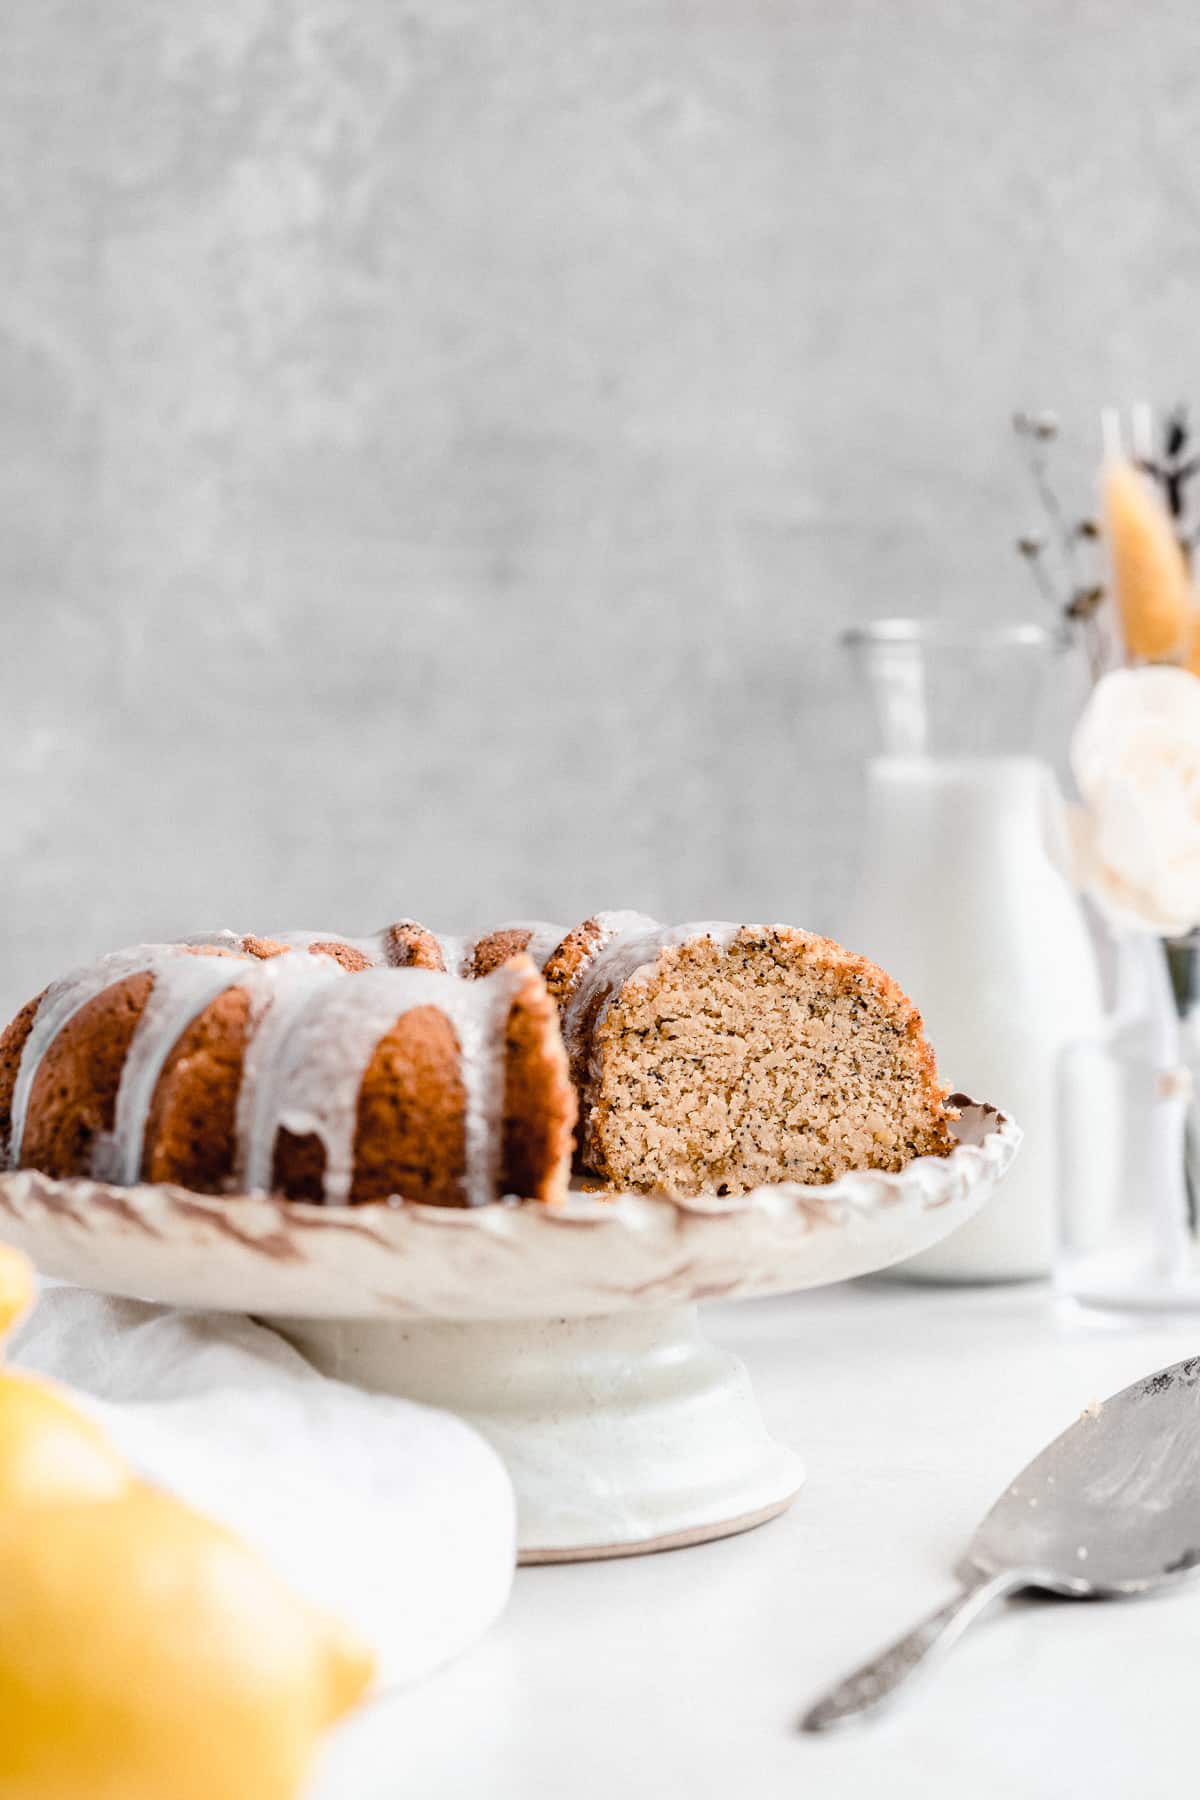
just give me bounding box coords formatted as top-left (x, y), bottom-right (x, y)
top-left (846, 619), bottom-right (1101, 1282)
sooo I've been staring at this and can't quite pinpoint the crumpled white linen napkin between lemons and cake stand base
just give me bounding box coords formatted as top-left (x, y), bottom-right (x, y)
top-left (7, 1285), bottom-right (516, 1685)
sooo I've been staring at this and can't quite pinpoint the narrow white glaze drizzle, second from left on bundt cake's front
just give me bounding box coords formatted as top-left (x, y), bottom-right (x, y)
top-left (92, 956), bottom-right (254, 1186)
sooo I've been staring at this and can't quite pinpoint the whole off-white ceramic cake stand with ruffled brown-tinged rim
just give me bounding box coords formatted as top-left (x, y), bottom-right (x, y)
top-left (0, 1100), bottom-right (1020, 1562)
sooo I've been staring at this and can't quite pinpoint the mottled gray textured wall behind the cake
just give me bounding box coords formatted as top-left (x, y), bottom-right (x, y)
top-left (0, 0), bottom-right (1200, 1010)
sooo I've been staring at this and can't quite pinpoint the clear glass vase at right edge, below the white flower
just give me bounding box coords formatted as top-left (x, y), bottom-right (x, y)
top-left (1058, 932), bottom-right (1200, 1312)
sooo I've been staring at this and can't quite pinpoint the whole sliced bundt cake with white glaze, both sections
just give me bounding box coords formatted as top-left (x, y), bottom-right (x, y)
top-left (0, 913), bottom-right (954, 1206)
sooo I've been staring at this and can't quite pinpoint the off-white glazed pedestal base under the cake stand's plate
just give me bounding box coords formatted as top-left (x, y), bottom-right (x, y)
top-left (272, 1307), bottom-right (804, 1562)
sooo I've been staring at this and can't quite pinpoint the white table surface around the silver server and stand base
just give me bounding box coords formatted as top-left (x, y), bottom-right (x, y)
top-left (313, 1283), bottom-right (1200, 1800)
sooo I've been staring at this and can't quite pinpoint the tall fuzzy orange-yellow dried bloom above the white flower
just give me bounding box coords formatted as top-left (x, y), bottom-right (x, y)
top-left (1103, 459), bottom-right (1193, 662)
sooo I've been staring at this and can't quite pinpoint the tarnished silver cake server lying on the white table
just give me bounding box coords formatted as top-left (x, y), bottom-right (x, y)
top-left (801, 1357), bottom-right (1200, 1732)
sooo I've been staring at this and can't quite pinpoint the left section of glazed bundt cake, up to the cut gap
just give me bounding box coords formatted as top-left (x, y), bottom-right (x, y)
top-left (0, 932), bottom-right (576, 1206)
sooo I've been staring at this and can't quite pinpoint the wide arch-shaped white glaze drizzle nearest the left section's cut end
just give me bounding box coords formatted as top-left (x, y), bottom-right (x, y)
top-left (239, 959), bottom-right (529, 1206)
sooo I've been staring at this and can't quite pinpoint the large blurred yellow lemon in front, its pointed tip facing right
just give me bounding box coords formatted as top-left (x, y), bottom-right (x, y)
top-left (0, 1483), bottom-right (372, 1800)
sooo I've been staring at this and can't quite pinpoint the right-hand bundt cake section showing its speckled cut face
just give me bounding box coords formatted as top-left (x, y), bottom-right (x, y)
top-left (561, 923), bottom-right (952, 1193)
